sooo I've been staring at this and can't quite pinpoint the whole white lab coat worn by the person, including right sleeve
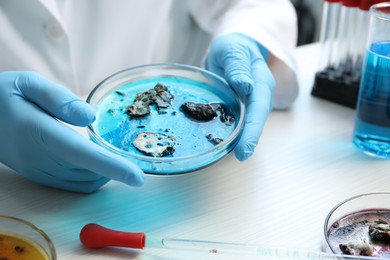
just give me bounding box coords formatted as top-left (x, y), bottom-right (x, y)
top-left (0, 0), bottom-right (298, 108)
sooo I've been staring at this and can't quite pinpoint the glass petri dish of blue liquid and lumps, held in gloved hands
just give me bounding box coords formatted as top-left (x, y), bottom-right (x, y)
top-left (87, 63), bottom-right (245, 175)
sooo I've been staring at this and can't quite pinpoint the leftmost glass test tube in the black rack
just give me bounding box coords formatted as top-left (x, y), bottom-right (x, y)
top-left (320, 0), bottom-right (341, 70)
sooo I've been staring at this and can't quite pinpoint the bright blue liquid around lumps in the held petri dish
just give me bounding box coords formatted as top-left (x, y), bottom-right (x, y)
top-left (93, 77), bottom-right (239, 157)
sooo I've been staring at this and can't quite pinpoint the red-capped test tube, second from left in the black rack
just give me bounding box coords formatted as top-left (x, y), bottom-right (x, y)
top-left (334, 0), bottom-right (359, 78)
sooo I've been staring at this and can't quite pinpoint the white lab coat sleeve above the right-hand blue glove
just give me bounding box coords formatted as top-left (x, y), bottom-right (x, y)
top-left (189, 0), bottom-right (298, 109)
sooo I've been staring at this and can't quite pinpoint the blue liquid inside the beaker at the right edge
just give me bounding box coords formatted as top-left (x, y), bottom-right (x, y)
top-left (353, 42), bottom-right (390, 158)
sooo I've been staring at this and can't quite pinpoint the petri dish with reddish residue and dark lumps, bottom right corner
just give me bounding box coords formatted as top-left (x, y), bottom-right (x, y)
top-left (324, 192), bottom-right (390, 259)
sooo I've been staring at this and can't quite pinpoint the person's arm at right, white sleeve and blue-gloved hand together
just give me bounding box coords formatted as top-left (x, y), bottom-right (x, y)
top-left (190, 0), bottom-right (298, 160)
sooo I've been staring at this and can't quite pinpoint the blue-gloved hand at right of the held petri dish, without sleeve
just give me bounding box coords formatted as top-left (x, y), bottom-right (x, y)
top-left (206, 33), bottom-right (275, 161)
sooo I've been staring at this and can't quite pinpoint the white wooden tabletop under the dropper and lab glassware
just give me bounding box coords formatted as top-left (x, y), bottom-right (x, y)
top-left (0, 41), bottom-right (390, 259)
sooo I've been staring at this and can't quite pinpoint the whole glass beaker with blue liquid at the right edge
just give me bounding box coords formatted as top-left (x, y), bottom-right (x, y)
top-left (353, 2), bottom-right (390, 158)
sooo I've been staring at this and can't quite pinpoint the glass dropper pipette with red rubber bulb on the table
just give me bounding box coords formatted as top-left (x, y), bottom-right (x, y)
top-left (80, 223), bottom-right (379, 260)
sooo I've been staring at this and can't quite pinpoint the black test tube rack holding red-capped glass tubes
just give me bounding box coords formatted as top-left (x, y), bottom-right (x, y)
top-left (311, 0), bottom-right (384, 109)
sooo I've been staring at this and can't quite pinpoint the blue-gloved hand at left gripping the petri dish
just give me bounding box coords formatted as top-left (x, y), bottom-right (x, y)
top-left (0, 72), bottom-right (144, 193)
